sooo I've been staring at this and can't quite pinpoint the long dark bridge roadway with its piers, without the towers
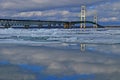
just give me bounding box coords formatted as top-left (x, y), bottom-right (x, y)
top-left (0, 19), bottom-right (102, 28)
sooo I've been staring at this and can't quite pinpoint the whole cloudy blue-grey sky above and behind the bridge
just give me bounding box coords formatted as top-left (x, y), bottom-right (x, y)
top-left (0, 0), bottom-right (120, 25)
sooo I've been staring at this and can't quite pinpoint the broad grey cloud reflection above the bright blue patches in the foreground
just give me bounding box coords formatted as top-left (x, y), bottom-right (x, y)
top-left (0, 45), bottom-right (120, 74)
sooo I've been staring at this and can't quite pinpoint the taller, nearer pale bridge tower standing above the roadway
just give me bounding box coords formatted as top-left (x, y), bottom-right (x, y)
top-left (80, 6), bottom-right (86, 28)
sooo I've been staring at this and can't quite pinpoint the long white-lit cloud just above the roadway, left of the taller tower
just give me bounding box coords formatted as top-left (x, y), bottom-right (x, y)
top-left (11, 9), bottom-right (79, 20)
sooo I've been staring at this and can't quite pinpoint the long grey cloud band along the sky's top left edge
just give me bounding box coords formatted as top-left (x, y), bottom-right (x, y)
top-left (0, 0), bottom-right (104, 10)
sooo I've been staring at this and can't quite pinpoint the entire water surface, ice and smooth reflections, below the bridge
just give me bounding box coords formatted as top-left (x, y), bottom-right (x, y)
top-left (0, 28), bottom-right (120, 80)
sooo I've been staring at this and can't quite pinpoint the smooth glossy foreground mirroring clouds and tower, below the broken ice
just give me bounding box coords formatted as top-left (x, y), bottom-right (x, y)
top-left (0, 43), bottom-right (120, 80)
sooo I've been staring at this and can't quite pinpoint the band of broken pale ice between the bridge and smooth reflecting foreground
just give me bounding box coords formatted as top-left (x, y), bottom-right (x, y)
top-left (0, 28), bottom-right (120, 44)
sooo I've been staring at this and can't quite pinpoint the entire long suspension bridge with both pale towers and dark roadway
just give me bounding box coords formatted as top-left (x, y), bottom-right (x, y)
top-left (0, 6), bottom-right (102, 28)
